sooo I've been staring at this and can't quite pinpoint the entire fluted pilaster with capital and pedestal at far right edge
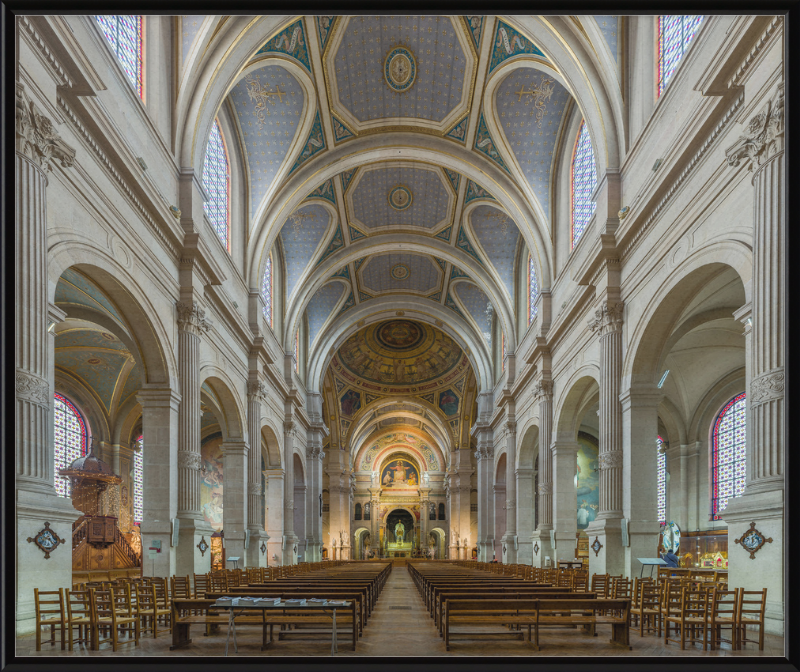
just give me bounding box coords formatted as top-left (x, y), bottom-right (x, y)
top-left (722, 82), bottom-right (786, 634)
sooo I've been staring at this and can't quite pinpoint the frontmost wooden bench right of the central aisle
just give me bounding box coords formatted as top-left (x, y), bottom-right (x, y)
top-left (442, 598), bottom-right (631, 651)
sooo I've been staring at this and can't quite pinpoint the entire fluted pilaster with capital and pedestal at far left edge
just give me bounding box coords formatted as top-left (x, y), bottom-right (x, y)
top-left (14, 83), bottom-right (80, 634)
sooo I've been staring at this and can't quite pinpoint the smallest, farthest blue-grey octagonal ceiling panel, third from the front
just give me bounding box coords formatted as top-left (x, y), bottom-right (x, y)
top-left (359, 252), bottom-right (442, 294)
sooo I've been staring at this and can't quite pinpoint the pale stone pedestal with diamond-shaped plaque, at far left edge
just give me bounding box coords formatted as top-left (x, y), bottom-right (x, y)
top-left (16, 488), bottom-right (81, 635)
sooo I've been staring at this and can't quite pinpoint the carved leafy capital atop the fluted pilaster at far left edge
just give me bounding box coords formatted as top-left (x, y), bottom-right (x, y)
top-left (15, 82), bottom-right (75, 172)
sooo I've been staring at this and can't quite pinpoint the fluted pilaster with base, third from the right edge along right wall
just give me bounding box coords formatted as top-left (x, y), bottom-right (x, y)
top-left (531, 378), bottom-right (555, 567)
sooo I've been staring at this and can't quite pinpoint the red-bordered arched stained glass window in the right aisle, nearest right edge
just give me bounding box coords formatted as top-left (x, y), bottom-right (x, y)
top-left (711, 392), bottom-right (747, 520)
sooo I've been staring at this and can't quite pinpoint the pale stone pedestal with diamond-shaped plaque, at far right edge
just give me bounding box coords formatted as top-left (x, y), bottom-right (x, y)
top-left (720, 485), bottom-right (780, 635)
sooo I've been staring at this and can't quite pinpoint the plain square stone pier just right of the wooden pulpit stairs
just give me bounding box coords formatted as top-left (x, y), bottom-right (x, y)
top-left (136, 389), bottom-right (181, 577)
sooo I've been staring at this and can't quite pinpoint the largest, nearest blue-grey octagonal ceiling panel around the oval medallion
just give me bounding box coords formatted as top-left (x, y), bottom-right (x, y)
top-left (329, 16), bottom-right (471, 123)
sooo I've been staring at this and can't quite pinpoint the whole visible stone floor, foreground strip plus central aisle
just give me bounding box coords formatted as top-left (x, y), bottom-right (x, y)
top-left (16, 567), bottom-right (784, 658)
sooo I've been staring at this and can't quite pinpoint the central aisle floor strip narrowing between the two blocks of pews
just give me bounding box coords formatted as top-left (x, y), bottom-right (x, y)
top-left (354, 565), bottom-right (447, 656)
